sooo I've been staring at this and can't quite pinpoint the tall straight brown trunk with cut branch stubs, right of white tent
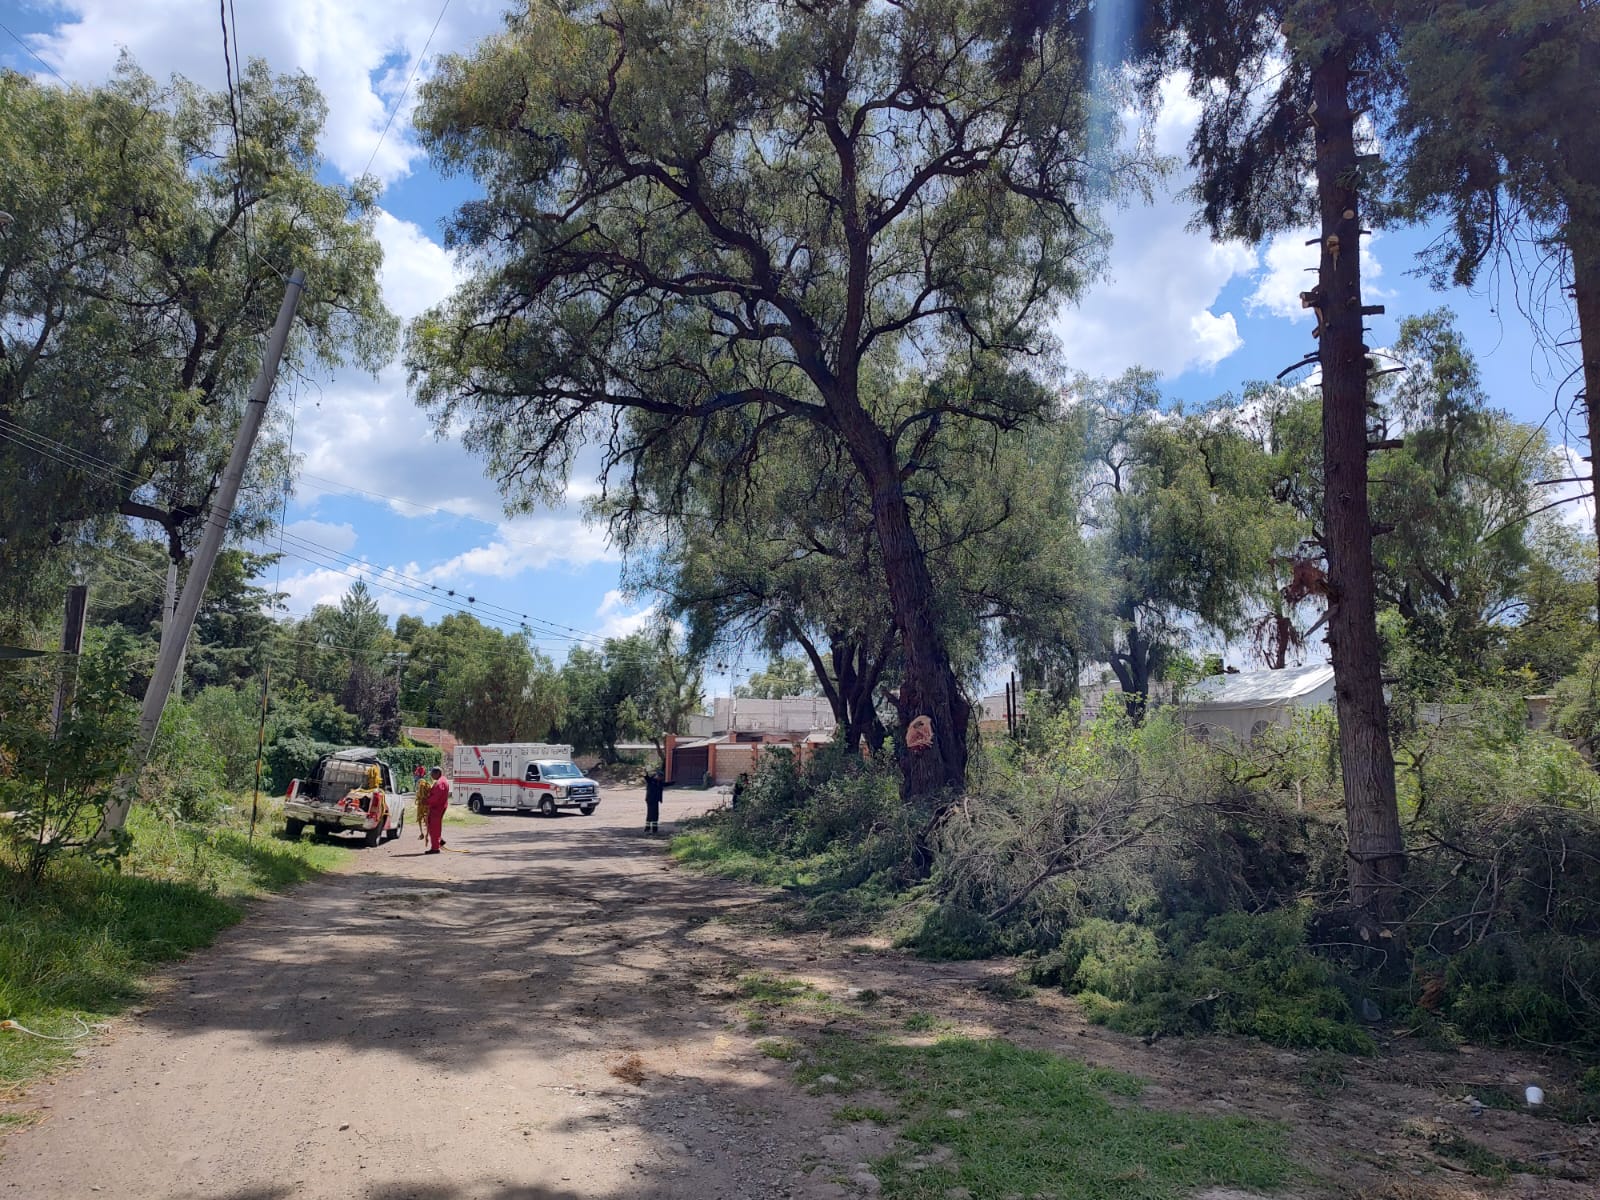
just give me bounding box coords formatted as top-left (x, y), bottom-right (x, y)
top-left (1312, 54), bottom-right (1405, 917)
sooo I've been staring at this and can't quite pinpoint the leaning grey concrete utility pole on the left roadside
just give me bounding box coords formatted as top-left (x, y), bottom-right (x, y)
top-left (101, 270), bottom-right (306, 834)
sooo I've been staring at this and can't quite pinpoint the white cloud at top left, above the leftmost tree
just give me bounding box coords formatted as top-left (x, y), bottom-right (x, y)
top-left (30, 0), bottom-right (504, 181)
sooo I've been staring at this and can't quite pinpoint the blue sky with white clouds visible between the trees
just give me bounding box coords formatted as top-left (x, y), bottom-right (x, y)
top-left (0, 0), bottom-right (1582, 674)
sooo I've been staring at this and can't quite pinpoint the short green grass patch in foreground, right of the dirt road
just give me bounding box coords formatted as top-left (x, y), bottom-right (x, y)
top-left (797, 1037), bottom-right (1299, 1200)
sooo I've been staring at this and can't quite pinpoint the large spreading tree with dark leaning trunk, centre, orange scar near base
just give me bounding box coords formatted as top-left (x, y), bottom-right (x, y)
top-left (408, 0), bottom-right (1145, 812)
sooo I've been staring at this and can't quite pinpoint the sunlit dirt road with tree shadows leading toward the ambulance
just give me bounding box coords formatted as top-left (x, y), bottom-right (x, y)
top-left (0, 789), bottom-right (870, 1200)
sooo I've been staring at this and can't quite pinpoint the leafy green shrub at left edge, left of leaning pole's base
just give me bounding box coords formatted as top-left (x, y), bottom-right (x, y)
top-left (0, 640), bottom-right (138, 883)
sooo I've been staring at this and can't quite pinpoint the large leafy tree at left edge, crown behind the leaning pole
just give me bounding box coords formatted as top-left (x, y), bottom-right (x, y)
top-left (0, 59), bottom-right (397, 620)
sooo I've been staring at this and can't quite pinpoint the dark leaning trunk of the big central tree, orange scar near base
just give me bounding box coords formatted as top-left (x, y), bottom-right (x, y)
top-left (834, 403), bottom-right (970, 802)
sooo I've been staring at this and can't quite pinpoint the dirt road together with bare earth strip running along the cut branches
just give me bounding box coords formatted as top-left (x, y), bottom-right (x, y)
top-left (0, 789), bottom-right (1597, 1200)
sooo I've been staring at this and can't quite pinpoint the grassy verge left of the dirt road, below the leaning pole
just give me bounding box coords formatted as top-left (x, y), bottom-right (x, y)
top-left (0, 802), bottom-right (350, 1096)
